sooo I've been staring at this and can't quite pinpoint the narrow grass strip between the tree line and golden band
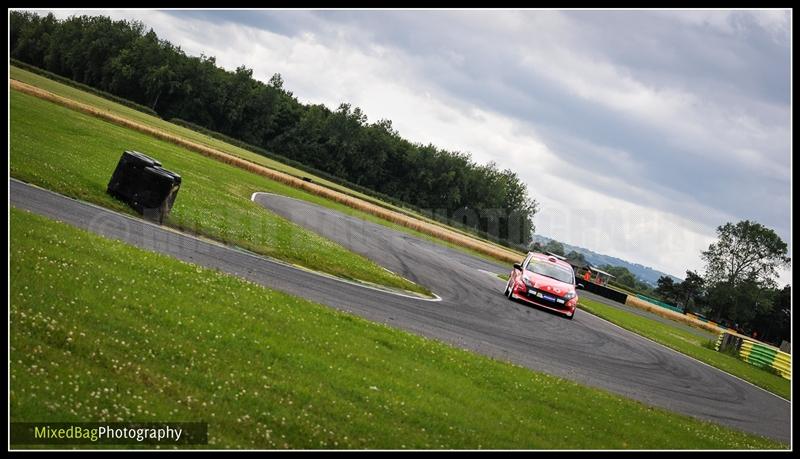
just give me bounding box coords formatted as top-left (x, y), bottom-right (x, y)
top-left (10, 66), bottom-right (520, 260)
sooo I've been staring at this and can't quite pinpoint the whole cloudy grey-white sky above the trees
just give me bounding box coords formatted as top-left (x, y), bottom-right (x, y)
top-left (40, 10), bottom-right (791, 282)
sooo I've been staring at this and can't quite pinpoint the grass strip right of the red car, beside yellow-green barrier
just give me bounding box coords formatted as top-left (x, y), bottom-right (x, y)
top-left (579, 299), bottom-right (792, 400)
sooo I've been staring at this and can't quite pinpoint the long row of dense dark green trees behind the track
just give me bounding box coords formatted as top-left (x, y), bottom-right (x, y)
top-left (9, 11), bottom-right (538, 245)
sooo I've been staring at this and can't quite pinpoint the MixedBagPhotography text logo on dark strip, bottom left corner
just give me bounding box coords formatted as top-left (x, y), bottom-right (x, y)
top-left (11, 422), bottom-right (208, 445)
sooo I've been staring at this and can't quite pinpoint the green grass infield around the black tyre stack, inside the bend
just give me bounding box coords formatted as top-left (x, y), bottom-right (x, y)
top-left (10, 91), bottom-right (429, 293)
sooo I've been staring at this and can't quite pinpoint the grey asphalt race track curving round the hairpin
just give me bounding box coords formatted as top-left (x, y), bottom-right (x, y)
top-left (9, 179), bottom-right (791, 443)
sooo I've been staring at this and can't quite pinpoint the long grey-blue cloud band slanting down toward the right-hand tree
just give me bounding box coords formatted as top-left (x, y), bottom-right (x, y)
top-left (384, 38), bottom-right (788, 241)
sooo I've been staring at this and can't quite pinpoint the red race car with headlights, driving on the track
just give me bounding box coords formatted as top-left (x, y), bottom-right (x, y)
top-left (505, 252), bottom-right (582, 319)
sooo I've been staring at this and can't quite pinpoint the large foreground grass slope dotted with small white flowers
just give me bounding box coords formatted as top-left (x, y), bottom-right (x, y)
top-left (9, 209), bottom-right (787, 449)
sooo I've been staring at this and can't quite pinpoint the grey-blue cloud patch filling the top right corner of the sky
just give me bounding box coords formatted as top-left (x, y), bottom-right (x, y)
top-left (566, 11), bottom-right (790, 104)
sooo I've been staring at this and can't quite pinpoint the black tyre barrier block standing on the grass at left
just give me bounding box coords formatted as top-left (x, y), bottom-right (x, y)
top-left (108, 151), bottom-right (181, 224)
